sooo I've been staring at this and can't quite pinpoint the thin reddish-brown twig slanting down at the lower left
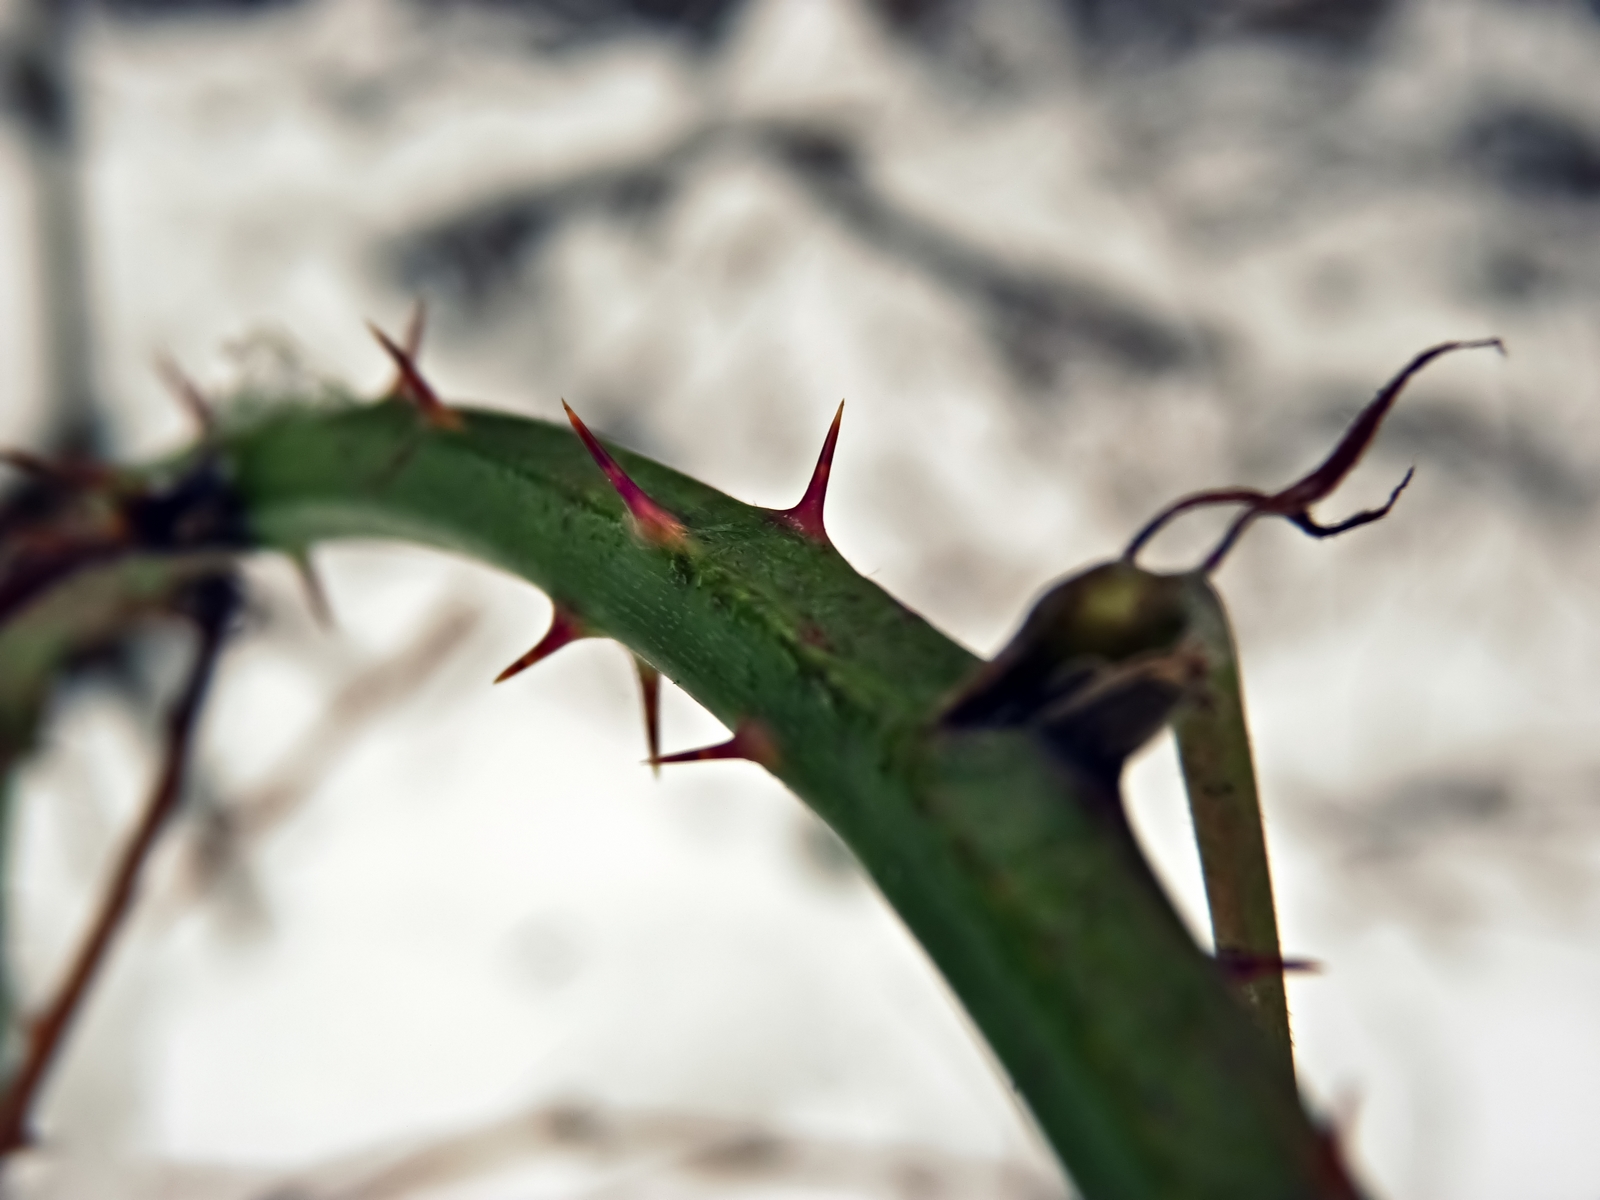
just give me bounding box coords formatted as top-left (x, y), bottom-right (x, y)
top-left (0, 576), bottom-right (238, 1157)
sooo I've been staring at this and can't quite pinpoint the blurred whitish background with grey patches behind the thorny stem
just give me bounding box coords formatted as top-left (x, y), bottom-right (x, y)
top-left (0, 0), bottom-right (1600, 1200)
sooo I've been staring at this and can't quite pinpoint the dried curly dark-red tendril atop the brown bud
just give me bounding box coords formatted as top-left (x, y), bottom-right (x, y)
top-left (1122, 338), bottom-right (1506, 574)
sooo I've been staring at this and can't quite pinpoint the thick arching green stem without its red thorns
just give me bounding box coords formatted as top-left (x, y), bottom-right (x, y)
top-left (209, 403), bottom-right (1354, 1200)
